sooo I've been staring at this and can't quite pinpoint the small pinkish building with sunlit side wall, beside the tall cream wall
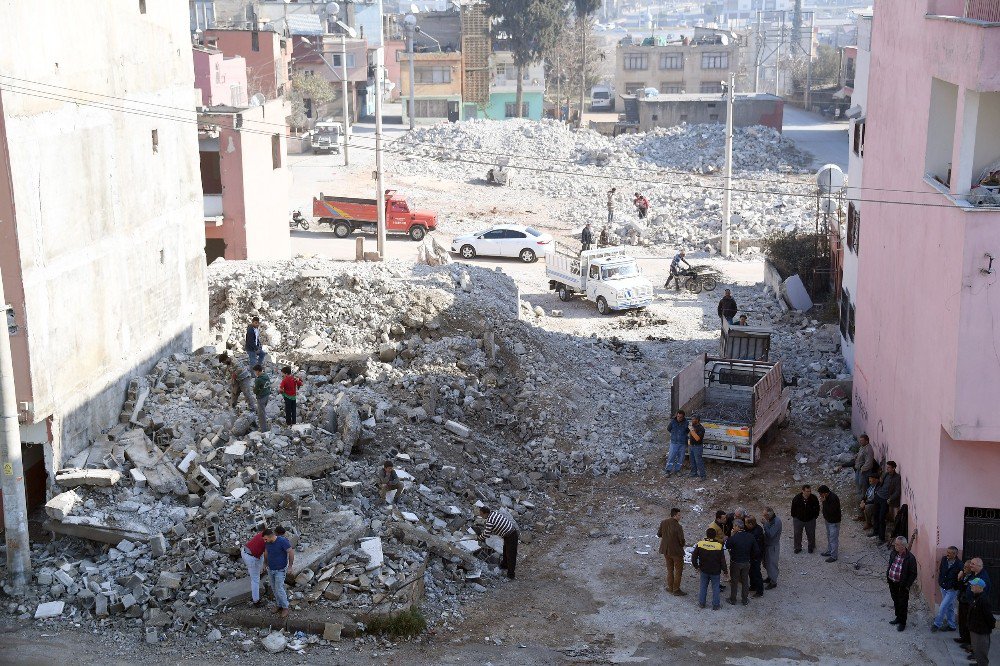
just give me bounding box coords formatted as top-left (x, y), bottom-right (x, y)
top-left (198, 100), bottom-right (291, 263)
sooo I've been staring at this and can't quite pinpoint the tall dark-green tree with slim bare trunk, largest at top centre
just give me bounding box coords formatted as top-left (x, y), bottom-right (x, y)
top-left (486, 0), bottom-right (566, 118)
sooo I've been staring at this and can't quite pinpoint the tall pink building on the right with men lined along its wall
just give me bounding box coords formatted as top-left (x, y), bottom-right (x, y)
top-left (853, 0), bottom-right (1000, 602)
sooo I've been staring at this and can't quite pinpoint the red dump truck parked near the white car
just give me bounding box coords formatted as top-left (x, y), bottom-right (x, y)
top-left (313, 190), bottom-right (437, 241)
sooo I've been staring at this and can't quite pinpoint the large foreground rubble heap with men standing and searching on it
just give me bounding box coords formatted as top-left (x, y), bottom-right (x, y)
top-left (18, 259), bottom-right (652, 642)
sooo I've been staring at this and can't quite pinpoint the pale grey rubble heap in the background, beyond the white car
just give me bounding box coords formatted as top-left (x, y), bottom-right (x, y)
top-left (389, 120), bottom-right (816, 247)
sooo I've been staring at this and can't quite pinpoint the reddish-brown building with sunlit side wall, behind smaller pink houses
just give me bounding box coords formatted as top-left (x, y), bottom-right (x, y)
top-left (203, 28), bottom-right (292, 99)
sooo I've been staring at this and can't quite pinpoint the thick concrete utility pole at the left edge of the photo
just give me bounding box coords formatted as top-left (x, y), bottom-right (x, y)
top-left (0, 276), bottom-right (31, 594)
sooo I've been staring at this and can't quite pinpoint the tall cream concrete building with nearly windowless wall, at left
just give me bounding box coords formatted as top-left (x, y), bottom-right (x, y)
top-left (0, 2), bottom-right (208, 504)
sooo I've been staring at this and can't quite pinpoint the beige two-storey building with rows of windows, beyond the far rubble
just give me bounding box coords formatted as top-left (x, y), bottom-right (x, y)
top-left (615, 30), bottom-right (741, 95)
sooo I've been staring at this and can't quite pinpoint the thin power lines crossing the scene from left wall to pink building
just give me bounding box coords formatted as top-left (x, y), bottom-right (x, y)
top-left (0, 74), bottom-right (935, 201)
